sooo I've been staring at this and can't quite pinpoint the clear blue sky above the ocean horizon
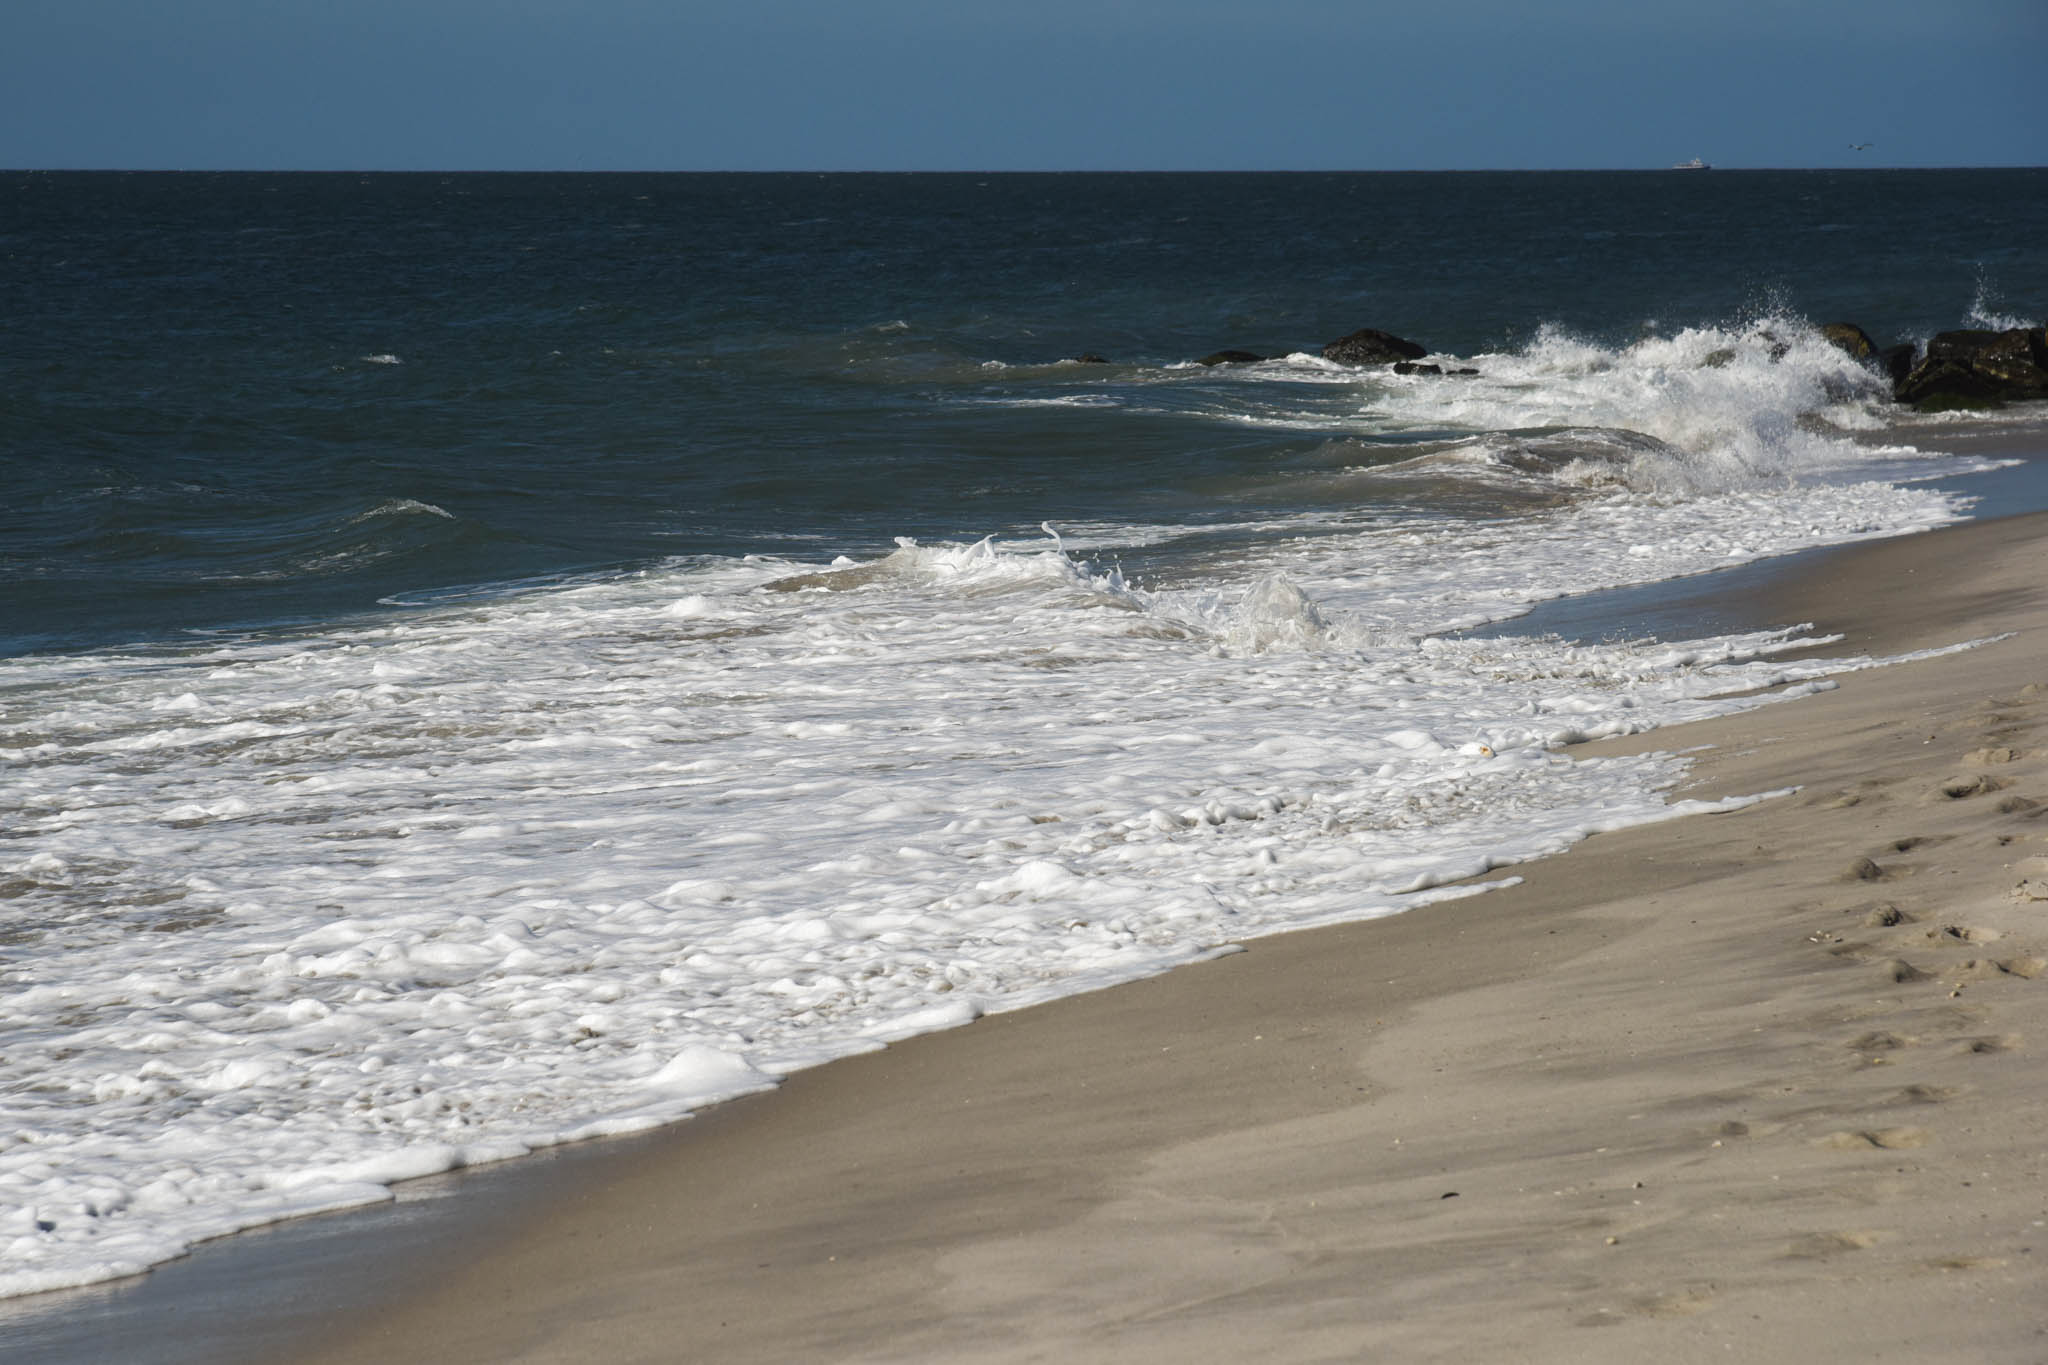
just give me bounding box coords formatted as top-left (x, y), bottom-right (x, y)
top-left (0, 0), bottom-right (2048, 170)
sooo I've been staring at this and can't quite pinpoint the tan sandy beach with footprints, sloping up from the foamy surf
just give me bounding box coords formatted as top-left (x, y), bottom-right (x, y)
top-left (305, 518), bottom-right (2048, 1363)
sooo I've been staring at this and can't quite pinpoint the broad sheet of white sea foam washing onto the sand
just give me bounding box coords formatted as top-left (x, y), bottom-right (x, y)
top-left (0, 454), bottom-right (1954, 1293)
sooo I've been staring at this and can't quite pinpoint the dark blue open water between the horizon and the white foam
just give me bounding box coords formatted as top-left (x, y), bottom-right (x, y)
top-left (0, 170), bottom-right (2048, 653)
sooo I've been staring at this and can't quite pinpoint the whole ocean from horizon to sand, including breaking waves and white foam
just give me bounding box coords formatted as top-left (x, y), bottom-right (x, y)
top-left (0, 170), bottom-right (2048, 1295)
